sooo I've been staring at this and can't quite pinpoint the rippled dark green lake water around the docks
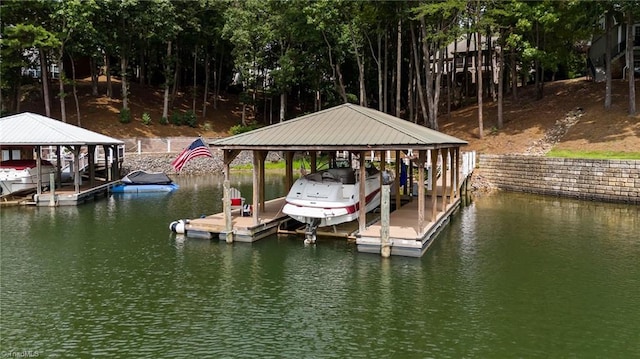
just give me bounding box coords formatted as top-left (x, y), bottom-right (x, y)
top-left (0, 174), bottom-right (640, 358)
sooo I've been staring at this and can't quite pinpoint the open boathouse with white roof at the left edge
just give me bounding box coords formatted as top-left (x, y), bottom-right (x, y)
top-left (0, 112), bottom-right (124, 206)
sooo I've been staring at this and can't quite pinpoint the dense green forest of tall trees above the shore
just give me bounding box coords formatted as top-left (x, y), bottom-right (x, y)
top-left (0, 0), bottom-right (640, 136)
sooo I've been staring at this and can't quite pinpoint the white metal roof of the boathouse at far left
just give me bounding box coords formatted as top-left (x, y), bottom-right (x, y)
top-left (0, 112), bottom-right (124, 146)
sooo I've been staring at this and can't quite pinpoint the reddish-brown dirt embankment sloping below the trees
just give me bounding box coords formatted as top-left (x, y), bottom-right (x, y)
top-left (21, 79), bottom-right (640, 155)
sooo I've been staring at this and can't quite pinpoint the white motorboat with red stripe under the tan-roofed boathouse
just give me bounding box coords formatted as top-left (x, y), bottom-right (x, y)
top-left (282, 167), bottom-right (380, 242)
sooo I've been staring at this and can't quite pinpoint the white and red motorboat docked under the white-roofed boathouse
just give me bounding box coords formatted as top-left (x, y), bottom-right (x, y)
top-left (0, 160), bottom-right (56, 197)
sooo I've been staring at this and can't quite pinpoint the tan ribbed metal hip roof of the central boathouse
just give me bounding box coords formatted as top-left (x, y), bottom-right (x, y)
top-left (210, 103), bottom-right (467, 151)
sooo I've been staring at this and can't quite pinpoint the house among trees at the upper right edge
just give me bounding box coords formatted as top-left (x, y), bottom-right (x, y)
top-left (587, 18), bottom-right (640, 82)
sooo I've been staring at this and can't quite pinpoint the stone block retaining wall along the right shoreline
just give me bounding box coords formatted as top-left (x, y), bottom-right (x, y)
top-left (477, 155), bottom-right (640, 204)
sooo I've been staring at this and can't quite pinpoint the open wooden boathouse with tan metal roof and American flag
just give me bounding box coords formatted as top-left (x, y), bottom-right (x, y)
top-left (186, 104), bottom-right (467, 256)
